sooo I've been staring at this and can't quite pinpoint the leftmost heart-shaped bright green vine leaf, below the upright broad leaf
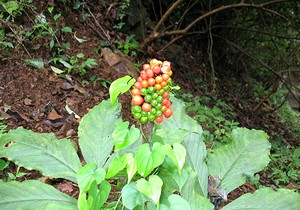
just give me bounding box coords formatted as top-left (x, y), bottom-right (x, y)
top-left (76, 163), bottom-right (106, 193)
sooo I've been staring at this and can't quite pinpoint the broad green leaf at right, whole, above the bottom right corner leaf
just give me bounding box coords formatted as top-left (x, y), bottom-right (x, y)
top-left (208, 128), bottom-right (271, 193)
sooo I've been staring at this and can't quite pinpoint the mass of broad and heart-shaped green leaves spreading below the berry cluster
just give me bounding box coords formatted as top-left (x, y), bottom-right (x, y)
top-left (0, 78), bottom-right (300, 210)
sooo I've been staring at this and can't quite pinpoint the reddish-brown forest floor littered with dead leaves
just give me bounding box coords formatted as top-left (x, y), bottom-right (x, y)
top-left (0, 1), bottom-right (298, 208)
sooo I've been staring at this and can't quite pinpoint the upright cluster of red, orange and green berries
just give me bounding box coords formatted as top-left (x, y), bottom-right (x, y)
top-left (131, 59), bottom-right (173, 124)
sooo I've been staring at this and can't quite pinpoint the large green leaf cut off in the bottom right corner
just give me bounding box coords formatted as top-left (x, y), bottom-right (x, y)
top-left (222, 188), bottom-right (300, 210)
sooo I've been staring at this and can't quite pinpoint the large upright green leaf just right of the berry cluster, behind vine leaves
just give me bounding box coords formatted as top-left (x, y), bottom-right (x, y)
top-left (154, 97), bottom-right (208, 196)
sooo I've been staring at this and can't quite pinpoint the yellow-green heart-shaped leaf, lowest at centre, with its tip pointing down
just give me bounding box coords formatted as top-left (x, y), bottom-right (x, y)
top-left (136, 175), bottom-right (163, 206)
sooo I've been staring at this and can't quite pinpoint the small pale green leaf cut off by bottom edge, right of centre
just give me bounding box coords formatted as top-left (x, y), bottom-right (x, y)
top-left (159, 194), bottom-right (191, 210)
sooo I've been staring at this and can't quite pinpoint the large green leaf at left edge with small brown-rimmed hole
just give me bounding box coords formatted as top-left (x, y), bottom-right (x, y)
top-left (0, 127), bottom-right (81, 182)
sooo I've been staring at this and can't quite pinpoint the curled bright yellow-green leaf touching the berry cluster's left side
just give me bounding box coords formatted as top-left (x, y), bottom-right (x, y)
top-left (109, 75), bottom-right (135, 104)
